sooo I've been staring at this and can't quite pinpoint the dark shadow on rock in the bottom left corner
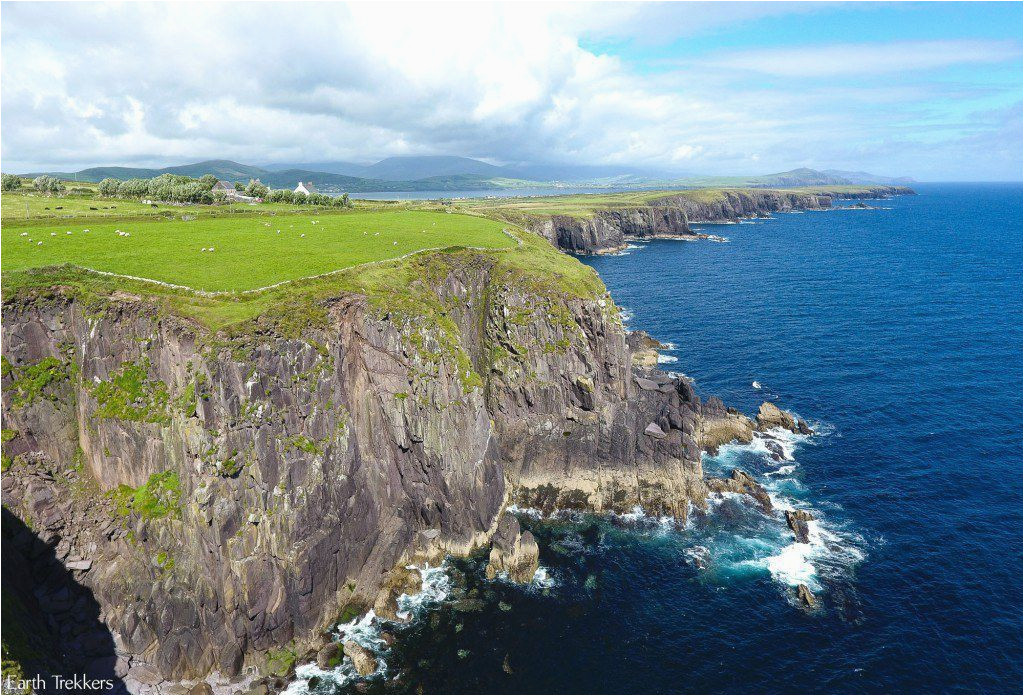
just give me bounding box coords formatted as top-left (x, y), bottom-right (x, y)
top-left (0, 506), bottom-right (128, 694)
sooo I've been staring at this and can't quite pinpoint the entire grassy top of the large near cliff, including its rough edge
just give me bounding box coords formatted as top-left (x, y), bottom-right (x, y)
top-left (0, 192), bottom-right (604, 335)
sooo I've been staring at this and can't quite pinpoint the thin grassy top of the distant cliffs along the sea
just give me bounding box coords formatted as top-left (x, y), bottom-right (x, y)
top-left (450, 185), bottom-right (905, 218)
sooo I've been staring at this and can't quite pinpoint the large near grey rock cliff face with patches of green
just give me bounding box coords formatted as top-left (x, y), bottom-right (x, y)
top-left (2, 244), bottom-right (750, 691)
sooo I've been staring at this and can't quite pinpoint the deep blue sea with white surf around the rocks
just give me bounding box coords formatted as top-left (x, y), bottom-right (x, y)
top-left (292, 184), bottom-right (1024, 693)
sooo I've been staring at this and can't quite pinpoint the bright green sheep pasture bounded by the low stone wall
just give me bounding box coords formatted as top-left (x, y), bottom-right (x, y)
top-left (2, 207), bottom-right (516, 292)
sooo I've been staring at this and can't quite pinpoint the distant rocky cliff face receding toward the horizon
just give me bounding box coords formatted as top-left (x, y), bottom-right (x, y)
top-left (527, 186), bottom-right (913, 254)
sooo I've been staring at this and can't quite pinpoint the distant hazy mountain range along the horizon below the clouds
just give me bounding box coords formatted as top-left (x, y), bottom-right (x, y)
top-left (26, 157), bottom-right (913, 193)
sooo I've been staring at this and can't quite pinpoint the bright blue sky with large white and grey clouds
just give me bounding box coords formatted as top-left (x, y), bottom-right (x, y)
top-left (0, 2), bottom-right (1024, 181)
